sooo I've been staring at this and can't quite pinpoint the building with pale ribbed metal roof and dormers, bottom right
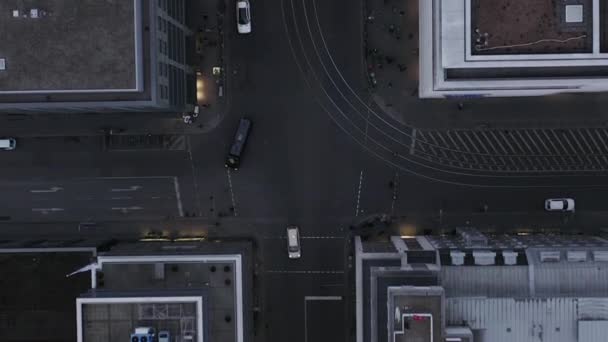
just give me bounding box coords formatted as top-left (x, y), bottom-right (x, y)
top-left (355, 232), bottom-right (608, 342)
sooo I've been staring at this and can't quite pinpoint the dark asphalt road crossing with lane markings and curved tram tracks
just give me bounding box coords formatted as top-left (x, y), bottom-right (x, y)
top-left (0, 0), bottom-right (608, 342)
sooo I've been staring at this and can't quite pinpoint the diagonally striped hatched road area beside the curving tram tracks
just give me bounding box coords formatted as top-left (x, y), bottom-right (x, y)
top-left (410, 128), bottom-right (608, 172)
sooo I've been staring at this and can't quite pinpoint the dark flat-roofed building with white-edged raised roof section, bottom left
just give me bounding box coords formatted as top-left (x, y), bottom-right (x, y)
top-left (78, 241), bottom-right (251, 342)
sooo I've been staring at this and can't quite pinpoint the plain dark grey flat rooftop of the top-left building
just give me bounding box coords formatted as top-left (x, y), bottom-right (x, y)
top-left (0, 0), bottom-right (137, 93)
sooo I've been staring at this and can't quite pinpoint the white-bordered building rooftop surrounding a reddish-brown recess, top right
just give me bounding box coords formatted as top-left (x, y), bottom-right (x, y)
top-left (419, 0), bottom-right (608, 98)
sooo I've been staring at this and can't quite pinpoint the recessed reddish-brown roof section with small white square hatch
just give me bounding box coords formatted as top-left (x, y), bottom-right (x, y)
top-left (471, 0), bottom-right (593, 55)
